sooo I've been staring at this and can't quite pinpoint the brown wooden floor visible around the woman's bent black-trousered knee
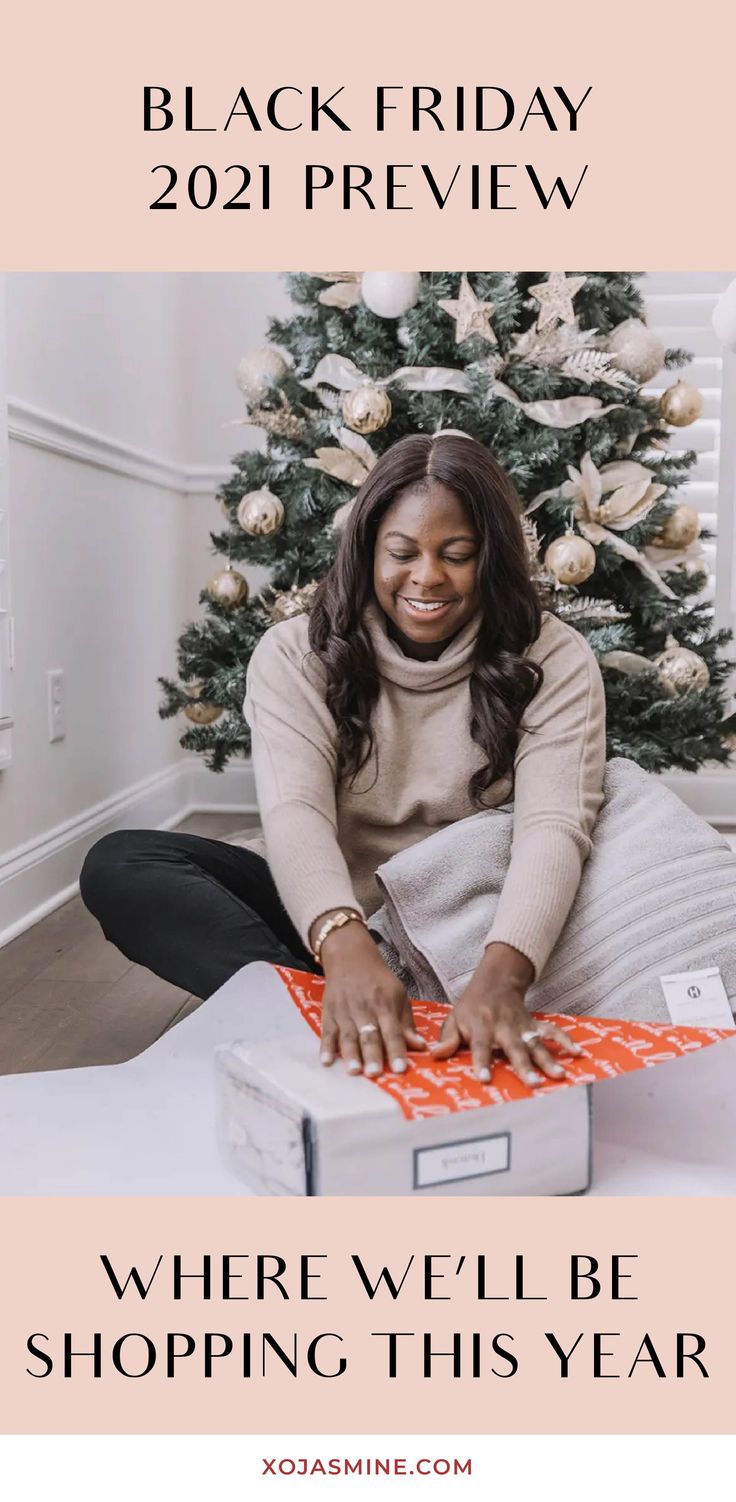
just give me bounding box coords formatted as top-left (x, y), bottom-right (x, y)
top-left (0, 814), bottom-right (257, 1074)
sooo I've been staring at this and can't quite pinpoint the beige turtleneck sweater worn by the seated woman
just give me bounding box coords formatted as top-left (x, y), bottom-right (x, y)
top-left (245, 604), bottom-right (605, 978)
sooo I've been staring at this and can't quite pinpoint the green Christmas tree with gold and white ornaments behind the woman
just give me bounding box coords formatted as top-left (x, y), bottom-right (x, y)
top-left (159, 272), bottom-right (736, 771)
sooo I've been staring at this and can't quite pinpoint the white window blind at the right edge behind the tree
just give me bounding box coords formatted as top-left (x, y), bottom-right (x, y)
top-left (641, 272), bottom-right (736, 625)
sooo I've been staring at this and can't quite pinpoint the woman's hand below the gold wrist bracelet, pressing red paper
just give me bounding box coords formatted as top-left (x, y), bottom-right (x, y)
top-left (315, 922), bottom-right (427, 1077)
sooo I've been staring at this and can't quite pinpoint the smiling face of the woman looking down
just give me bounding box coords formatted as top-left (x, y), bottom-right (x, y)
top-left (374, 479), bottom-right (478, 656)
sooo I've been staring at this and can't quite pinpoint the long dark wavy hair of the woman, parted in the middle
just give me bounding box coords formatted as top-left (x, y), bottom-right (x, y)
top-left (309, 433), bottom-right (542, 807)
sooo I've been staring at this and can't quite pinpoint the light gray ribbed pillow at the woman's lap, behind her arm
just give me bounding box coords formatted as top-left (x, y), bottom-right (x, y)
top-left (370, 757), bottom-right (736, 1021)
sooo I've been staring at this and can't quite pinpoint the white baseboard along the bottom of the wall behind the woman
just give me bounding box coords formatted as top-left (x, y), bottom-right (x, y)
top-left (0, 756), bottom-right (736, 946)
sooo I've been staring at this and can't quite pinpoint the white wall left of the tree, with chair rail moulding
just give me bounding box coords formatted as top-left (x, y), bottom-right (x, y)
top-left (0, 275), bottom-right (191, 933)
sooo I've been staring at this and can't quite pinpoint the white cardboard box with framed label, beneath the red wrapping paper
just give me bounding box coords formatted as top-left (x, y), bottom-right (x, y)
top-left (216, 988), bottom-right (592, 1196)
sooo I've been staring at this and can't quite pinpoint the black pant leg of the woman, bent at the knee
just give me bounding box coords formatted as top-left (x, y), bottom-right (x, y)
top-left (80, 829), bottom-right (321, 997)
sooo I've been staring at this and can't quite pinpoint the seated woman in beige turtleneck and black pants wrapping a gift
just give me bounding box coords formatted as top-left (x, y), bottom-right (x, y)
top-left (81, 434), bottom-right (605, 1084)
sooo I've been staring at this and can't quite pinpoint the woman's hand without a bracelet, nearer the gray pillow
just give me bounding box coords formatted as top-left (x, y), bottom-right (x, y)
top-left (433, 943), bottom-right (583, 1084)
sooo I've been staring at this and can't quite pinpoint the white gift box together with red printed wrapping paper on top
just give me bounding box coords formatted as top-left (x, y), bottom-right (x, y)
top-left (216, 966), bottom-right (733, 1196)
